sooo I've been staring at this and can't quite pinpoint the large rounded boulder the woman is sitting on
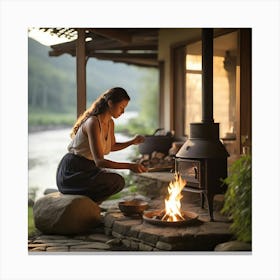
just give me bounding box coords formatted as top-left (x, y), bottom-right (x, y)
top-left (33, 192), bottom-right (101, 234)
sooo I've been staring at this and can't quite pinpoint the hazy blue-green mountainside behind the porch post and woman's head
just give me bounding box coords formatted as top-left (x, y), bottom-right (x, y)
top-left (28, 38), bottom-right (157, 112)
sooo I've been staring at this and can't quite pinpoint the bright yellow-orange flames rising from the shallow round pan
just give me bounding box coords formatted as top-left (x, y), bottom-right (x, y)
top-left (161, 172), bottom-right (186, 222)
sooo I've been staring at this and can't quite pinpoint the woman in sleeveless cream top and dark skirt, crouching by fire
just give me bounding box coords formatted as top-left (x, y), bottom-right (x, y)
top-left (56, 87), bottom-right (146, 204)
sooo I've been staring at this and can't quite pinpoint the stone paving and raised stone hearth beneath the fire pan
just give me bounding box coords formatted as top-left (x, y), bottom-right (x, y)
top-left (28, 190), bottom-right (234, 254)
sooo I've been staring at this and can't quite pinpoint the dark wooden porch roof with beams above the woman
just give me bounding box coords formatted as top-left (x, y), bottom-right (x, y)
top-left (40, 28), bottom-right (159, 67)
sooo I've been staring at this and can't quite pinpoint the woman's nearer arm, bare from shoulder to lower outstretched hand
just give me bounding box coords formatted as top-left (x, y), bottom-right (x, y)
top-left (83, 117), bottom-right (146, 173)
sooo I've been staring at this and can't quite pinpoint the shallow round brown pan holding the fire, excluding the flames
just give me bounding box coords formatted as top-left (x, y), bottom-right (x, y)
top-left (143, 210), bottom-right (198, 227)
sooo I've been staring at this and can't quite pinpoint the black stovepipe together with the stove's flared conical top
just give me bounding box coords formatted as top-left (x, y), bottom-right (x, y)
top-left (176, 28), bottom-right (229, 159)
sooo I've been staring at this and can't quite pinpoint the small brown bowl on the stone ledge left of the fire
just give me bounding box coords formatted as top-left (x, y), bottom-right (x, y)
top-left (119, 199), bottom-right (149, 216)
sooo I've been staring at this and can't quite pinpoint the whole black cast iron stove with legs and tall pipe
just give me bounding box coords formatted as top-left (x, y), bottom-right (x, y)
top-left (175, 28), bottom-right (229, 221)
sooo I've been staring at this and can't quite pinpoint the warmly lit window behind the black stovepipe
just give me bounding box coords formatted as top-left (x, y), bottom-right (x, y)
top-left (185, 32), bottom-right (239, 145)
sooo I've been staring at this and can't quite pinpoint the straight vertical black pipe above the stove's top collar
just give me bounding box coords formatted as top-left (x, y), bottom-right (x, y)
top-left (202, 28), bottom-right (214, 123)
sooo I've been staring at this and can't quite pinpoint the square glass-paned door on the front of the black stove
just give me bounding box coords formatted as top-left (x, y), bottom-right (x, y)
top-left (175, 158), bottom-right (203, 189)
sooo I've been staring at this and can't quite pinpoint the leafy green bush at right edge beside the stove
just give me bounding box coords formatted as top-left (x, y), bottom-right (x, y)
top-left (221, 155), bottom-right (252, 242)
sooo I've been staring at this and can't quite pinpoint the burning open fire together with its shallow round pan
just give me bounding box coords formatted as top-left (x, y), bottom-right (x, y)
top-left (143, 172), bottom-right (198, 226)
